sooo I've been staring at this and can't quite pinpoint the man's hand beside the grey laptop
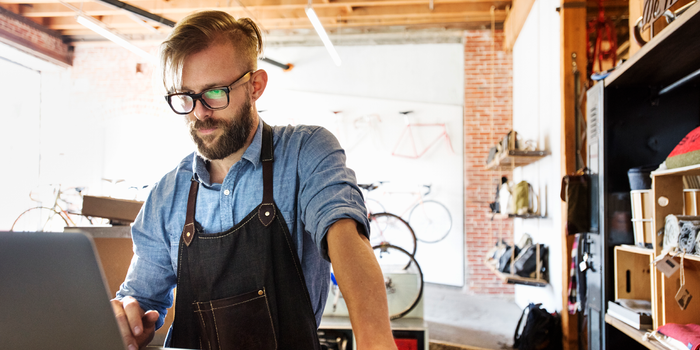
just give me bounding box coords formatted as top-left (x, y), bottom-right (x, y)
top-left (112, 297), bottom-right (158, 350)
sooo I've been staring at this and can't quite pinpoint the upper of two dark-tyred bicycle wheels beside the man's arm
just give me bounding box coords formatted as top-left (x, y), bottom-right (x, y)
top-left (369, 213), bottom-right (416, 255)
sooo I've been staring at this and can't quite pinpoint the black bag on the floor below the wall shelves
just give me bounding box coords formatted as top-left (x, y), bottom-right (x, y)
top-left (513, 303), bottom-right (562, 350)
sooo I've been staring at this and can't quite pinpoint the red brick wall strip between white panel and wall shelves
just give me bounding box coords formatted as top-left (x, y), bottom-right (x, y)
top-left (464, 30), bottom-right (514, 294)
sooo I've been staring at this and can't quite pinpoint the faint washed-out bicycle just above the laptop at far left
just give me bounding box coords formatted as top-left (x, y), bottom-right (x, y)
top-left (10, 185), bottom-right (93, 232)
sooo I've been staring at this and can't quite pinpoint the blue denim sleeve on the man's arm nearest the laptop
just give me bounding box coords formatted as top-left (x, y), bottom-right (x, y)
top-left (116, 180), bottom-right (177, 328)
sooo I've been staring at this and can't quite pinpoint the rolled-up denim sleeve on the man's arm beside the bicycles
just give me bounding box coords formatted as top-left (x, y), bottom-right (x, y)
top-left (298, 128), bottom-right (369, 261)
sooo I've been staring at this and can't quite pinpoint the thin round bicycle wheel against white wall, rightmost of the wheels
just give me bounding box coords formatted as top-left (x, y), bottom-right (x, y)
top-left (408, 200), bottom-right (452, 243)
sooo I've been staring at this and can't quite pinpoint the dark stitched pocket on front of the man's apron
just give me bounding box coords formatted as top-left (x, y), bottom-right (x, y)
top-left (192, 288), bottom-right (277, 350)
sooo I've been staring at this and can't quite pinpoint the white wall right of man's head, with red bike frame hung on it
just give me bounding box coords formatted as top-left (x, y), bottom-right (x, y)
top-left (257, 44), bottom-right (464, 286)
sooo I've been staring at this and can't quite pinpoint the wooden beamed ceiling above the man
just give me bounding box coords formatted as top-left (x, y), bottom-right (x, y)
top-left (0, 0), bottom-right (627, 44)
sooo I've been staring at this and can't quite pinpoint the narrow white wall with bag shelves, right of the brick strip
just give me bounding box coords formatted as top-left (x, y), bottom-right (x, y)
top-left (513, 0), bottom-right (562, 311)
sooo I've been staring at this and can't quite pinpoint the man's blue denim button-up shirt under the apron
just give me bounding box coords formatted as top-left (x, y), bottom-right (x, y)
top-left (117, 120), bottom-right (369, 328)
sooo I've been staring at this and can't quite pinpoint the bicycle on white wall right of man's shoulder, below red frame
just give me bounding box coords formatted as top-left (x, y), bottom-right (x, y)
top-left (369, 182), bottom-right (452, 245)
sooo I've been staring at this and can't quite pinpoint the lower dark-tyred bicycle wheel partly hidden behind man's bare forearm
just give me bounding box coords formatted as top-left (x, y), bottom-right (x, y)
top-left (372, 243), bottom-right (423, 320)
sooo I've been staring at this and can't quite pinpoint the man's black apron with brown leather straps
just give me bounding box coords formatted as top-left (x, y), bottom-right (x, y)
top-left (170, 121), bottom-right (320, 350)
